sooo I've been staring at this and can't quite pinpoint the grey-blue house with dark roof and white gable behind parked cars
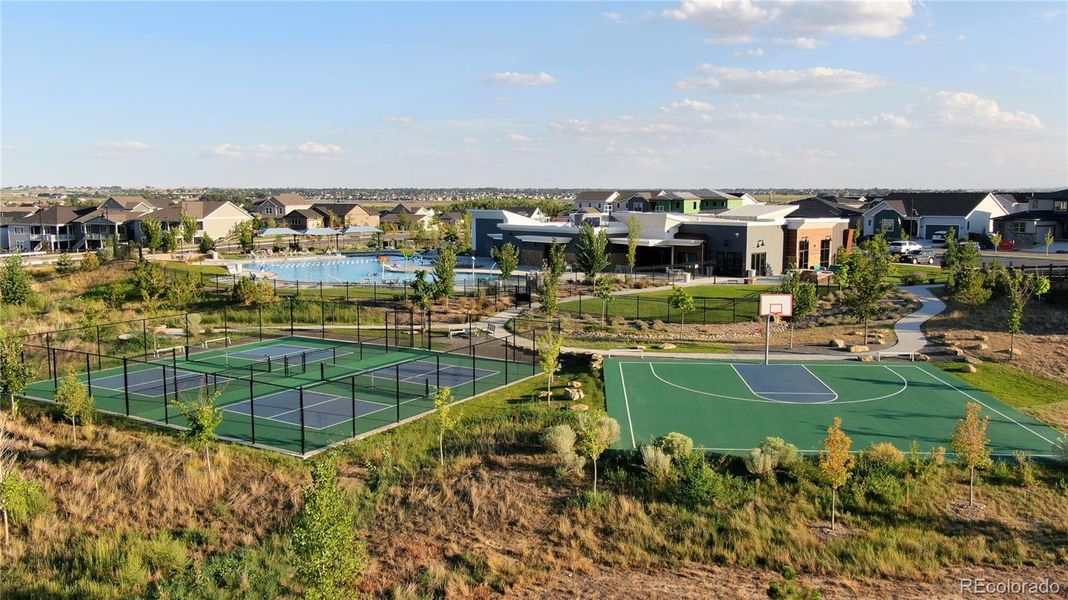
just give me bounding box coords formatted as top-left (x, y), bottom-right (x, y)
top-left (863, 192), bottom-right (1011, 239)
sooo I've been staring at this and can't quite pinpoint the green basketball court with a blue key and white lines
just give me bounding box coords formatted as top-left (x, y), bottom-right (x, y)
top-left (604, 358), bottom-right (1059, 456)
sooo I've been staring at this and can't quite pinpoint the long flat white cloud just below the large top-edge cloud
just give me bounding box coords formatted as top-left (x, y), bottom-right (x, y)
top-left (676, 64), bottom-right (888, 95)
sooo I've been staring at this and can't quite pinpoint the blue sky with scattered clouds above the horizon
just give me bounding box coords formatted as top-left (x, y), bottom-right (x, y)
top-left (0, 0), bottom-right (1068, 188)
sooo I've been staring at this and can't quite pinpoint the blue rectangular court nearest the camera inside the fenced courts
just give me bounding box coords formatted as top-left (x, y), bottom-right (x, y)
top-left (225, 390), bottom-right (394, 429)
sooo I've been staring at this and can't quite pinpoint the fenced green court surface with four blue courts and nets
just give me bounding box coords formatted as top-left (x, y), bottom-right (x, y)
top-left (25, 336), bottom-right (537, 455)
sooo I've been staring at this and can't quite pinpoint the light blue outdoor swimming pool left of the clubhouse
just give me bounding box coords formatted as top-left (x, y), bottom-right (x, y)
top-left (241, 256), bottom-right (497, 283)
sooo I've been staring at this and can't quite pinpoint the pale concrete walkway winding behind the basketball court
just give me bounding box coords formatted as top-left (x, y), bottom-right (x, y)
top-left (475, 285), bottom-right (946, 361)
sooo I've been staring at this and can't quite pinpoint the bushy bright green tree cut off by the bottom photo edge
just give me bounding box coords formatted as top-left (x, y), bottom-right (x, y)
top-left (290, 460), bottom-right (367, 600)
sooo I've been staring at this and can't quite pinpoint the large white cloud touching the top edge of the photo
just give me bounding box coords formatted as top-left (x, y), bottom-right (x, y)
top-left (662, 0), bottom-right (912, 37)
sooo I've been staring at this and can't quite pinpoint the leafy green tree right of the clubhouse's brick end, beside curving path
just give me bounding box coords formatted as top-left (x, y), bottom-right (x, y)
top-left (838, 234), bottom-right (897, 340)
